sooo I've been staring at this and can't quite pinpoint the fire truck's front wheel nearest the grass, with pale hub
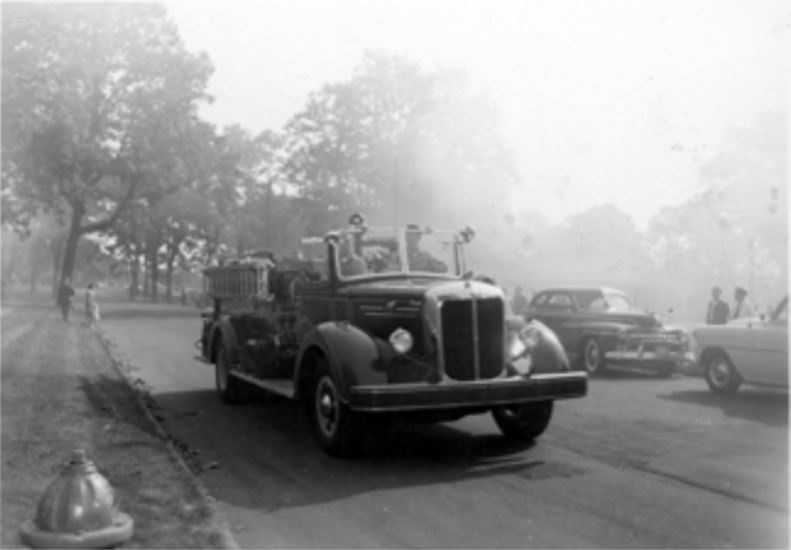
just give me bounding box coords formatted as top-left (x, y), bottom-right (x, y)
top-left (308, 359), bottom-right (362, 458)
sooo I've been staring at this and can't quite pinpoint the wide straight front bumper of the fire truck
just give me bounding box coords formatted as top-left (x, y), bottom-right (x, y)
top-left (349, 372), bottom-right (588, 412)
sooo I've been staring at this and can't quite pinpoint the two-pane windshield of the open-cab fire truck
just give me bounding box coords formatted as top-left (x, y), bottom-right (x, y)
top-left (336, 228), bottom-right (459, 278)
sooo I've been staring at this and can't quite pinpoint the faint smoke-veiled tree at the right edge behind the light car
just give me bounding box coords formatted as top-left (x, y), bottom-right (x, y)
top-left (647, 113), bottom-right (788, 316)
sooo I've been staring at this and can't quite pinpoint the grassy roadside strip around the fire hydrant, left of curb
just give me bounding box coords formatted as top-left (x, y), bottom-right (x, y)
top-left (0, 302), bottom-right (235, 548)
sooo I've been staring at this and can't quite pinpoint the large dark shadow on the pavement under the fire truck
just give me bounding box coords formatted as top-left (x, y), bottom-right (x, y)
top-left (147, 391), bottom-right (584, 511)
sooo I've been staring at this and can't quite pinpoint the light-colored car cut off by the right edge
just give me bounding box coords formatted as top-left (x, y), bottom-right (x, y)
top-left (691, 296), bottom-right (788, 395)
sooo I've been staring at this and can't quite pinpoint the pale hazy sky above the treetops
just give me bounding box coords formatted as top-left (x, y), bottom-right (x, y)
top-left (166, 0), bottom-right (791, 226)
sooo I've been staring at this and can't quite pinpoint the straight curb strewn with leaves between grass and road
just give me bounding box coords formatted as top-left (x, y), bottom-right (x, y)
top-left (96, 328), bottom-right (239, 550)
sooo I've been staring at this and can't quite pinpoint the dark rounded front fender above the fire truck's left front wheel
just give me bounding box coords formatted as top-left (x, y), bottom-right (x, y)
top-left (294, 321), bottom-right (387, 401)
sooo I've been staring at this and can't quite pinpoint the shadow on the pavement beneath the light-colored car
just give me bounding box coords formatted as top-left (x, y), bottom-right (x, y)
top-left (657, 388), bottom-right (788, 427)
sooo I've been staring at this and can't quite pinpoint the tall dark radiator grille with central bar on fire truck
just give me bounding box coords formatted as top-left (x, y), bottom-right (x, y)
top-left (441, 298), bottom-right (505, 380)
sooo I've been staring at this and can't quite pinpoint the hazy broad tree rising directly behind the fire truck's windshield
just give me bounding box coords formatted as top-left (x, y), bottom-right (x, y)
top-left (284, 52), bottom-right (518, 232)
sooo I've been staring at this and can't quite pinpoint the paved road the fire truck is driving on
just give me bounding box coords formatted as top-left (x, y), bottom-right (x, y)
top-left (103, 304), bottom-right (789, 548)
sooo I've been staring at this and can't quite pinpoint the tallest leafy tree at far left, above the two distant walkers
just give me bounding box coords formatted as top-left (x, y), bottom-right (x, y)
top-left (2, 3), bottom-right (211, 294)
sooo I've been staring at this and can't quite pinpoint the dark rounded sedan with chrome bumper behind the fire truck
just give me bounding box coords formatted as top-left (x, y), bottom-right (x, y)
top-left (525, 287), bottom-right (689, 376)
